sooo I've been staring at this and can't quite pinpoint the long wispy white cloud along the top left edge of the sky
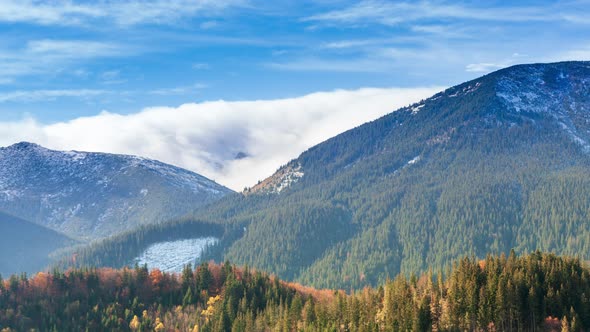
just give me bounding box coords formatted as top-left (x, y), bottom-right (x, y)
top-left (0, 0), bottom-right (244, 26)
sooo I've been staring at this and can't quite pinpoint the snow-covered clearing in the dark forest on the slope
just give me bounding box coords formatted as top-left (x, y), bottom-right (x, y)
top-left (134, 237), bottom-right (219, 272)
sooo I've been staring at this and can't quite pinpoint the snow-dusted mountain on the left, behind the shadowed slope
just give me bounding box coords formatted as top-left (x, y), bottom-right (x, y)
top-left (0, 142), bottom-right (232, 239)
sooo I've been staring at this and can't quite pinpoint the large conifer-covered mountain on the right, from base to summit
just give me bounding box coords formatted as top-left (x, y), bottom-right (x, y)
top-left (70, 62), bottom-right (590, 289)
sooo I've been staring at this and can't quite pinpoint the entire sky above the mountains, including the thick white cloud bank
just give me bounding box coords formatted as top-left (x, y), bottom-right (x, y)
top-left (0, 0), bottom-right (590, 190)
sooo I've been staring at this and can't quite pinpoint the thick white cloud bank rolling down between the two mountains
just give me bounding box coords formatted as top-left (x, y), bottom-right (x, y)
top-left (0, 88), bottom-right (440, 190)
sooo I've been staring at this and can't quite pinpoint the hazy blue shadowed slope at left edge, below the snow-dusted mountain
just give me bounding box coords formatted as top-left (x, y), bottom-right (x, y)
top-left (0, 212), bottom-right (76, 276)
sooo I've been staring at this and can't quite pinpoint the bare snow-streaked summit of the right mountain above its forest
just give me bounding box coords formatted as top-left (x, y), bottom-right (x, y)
top-left (386, 61), bottom-right (590, 152)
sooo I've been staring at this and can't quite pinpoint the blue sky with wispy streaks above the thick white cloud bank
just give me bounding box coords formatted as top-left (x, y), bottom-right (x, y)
top-left (0, 0), bottom-right (590, 122)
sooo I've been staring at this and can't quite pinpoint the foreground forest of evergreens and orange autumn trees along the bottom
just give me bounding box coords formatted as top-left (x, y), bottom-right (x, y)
top-left (0, 252), bottom-right (590, 332)
